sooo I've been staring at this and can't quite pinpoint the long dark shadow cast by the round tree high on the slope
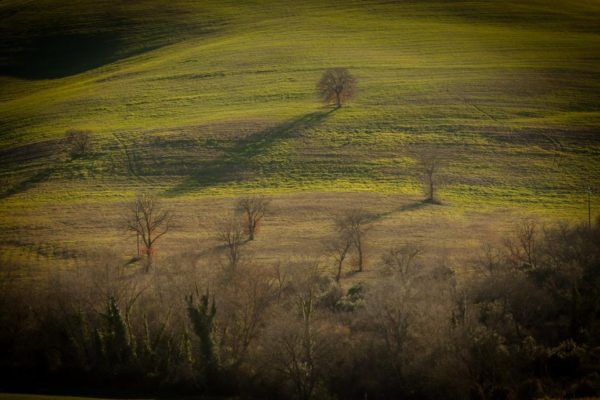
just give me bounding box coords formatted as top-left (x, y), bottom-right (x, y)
top-left (165, 109), bottom-right (335, 196)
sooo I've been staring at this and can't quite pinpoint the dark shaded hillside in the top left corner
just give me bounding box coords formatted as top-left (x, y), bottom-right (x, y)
top-left (0, 0), bottom-right (225, 79)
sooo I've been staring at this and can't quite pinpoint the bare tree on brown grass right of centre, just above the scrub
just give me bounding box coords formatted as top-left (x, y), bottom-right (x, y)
top-left (334, 209), bottom-right (372, 272)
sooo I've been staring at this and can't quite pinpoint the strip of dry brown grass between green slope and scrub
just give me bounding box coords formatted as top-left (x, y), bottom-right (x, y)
top-left (0, 193), bottom-right (544, 282)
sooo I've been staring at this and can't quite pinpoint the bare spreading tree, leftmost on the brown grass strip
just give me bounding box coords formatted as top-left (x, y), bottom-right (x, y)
top-left (126, 193), bottom-right (173, 272)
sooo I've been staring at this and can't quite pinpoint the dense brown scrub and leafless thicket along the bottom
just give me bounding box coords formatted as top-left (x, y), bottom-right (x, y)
top-left (0, 216), bottom-right (600, 399)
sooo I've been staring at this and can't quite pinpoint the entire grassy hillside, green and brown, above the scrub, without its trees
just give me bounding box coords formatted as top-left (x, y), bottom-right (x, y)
top-left (0, 0), bottom-right (600, 264)
